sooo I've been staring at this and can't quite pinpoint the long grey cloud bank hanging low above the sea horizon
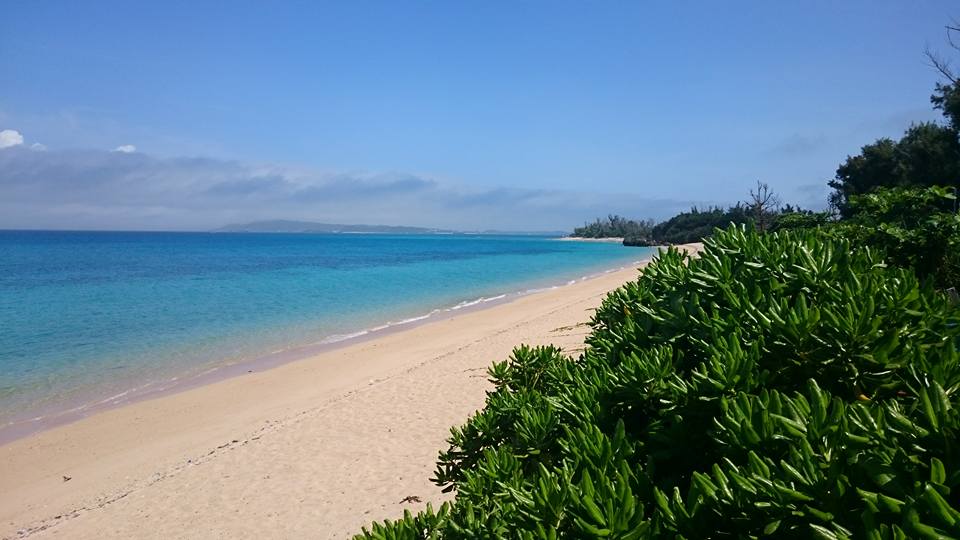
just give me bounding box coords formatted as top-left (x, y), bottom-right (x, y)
top-left (0, 144), bottom-right (704, 230)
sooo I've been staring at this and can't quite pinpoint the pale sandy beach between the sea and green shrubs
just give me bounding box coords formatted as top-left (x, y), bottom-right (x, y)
top-left (0, 246), bottom-right (700, 539)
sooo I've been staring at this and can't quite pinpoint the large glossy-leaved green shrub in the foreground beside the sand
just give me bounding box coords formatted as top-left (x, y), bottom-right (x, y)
top-left (360, 226), bottom-right (960, 539)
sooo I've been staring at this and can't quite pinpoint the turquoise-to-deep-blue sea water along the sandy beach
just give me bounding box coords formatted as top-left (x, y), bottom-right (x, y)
top-left (0, 231), bottom-right (650, 428)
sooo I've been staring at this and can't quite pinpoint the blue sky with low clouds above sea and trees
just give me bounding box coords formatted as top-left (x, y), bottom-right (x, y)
top-left (0, 0), bottom-right (960, 230)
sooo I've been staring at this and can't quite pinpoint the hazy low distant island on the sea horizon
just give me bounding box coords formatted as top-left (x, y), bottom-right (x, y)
top-left (218, 219), bottom-right (568, 236)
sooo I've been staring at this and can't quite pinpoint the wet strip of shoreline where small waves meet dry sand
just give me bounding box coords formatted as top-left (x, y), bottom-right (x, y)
top-left (0, 251), bottom-right (656, 447)
